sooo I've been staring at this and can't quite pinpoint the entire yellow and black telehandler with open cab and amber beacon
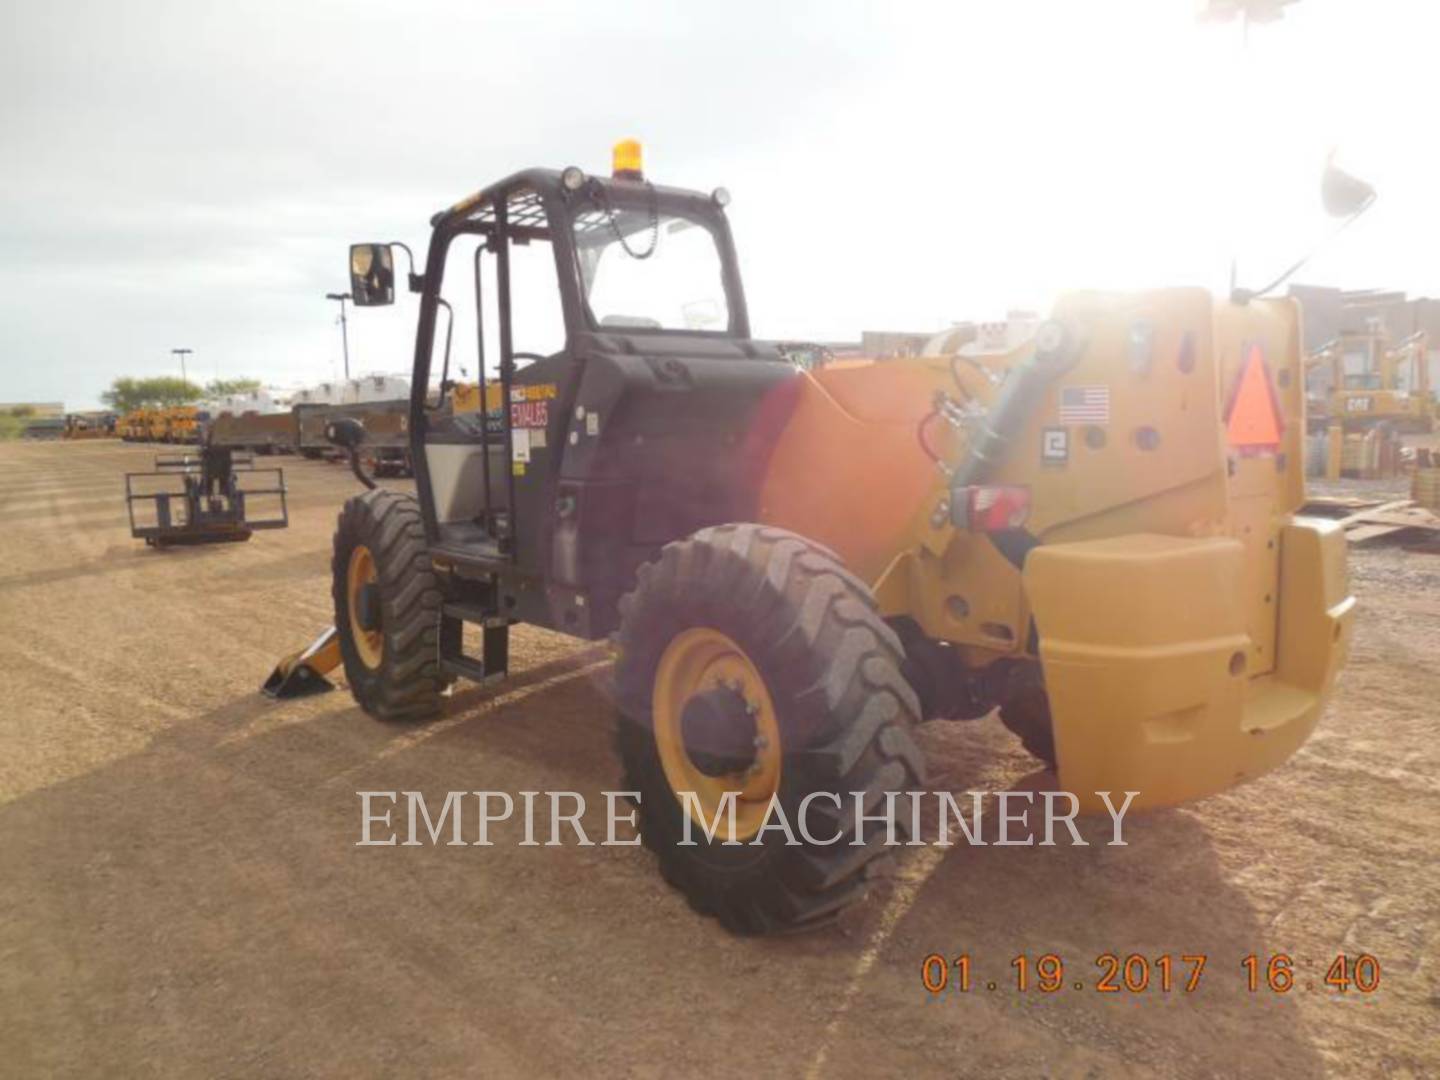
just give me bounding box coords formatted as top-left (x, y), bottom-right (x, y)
top-left (266, 143), bottom-right (1354, 933)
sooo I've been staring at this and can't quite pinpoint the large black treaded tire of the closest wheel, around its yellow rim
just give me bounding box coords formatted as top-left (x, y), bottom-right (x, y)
top-left (615, 524), bottom-right (924, 933)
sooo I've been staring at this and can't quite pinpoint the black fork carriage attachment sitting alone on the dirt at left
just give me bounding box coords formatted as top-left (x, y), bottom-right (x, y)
top-left (125, 446), bottom-right (289, 547)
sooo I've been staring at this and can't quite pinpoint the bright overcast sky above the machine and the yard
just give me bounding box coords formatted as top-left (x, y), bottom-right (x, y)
top-left (0, 0), bottom-right (1440, 409)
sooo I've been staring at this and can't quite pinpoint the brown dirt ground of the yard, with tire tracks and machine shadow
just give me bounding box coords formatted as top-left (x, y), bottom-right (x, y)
top-left (0, 442), bottom-right (1440, 1077)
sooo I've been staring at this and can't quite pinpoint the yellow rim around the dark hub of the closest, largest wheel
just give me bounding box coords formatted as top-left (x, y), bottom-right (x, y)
top-left (651, 626), bottom-right (782, 842)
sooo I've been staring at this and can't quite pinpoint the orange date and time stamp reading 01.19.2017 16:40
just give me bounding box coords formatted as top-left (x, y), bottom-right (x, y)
top-left (920, 952), bottom-right (1380, 998)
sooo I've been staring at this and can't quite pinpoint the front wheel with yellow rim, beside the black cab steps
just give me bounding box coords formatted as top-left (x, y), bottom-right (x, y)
top-left (331, 488), bottom-right (445, 720)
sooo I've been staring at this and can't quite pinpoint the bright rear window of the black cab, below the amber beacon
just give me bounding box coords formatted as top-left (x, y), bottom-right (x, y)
top-left (575, 192), bottom-right (730, 333)
